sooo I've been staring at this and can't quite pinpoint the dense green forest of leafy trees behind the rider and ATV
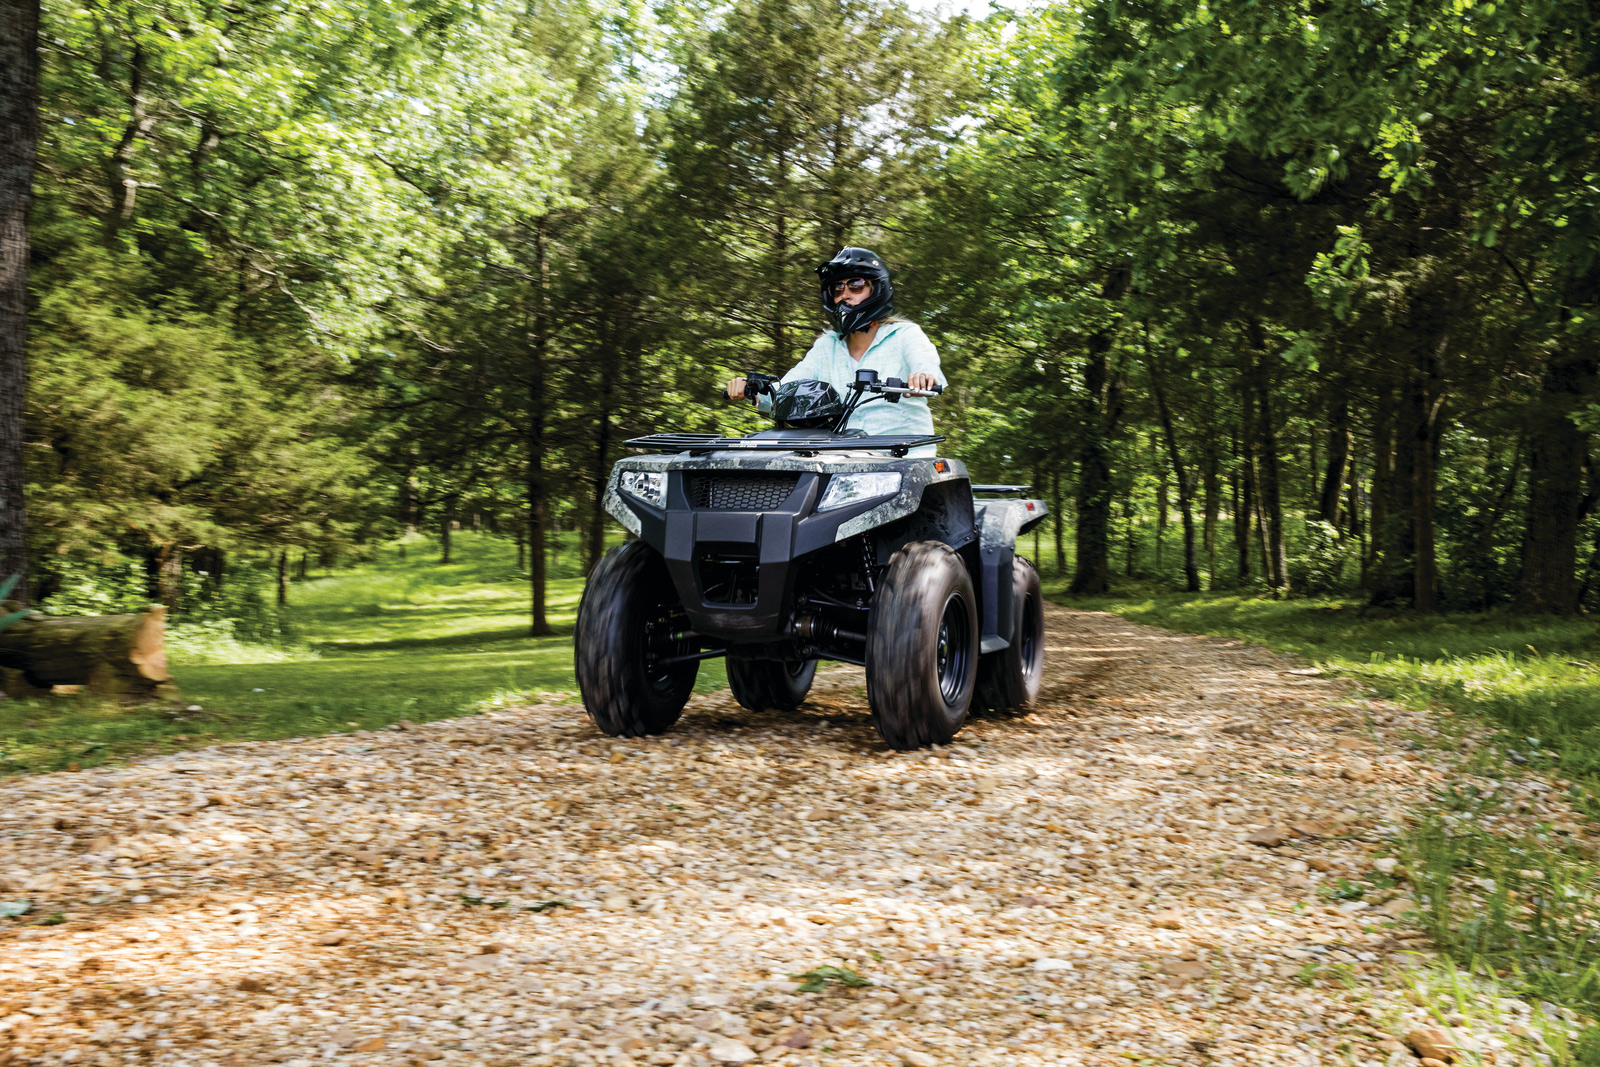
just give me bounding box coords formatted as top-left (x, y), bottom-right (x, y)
top-left (0, 0), bottom-right (1600, 635)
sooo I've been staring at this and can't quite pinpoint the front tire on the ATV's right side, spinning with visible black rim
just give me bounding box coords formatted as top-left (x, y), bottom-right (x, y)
top-left (867, 541), bottom-right (978, 750)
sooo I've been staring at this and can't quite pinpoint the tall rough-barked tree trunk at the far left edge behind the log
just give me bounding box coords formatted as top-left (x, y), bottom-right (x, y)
top-left (0, 0), bottom-right (38, 603)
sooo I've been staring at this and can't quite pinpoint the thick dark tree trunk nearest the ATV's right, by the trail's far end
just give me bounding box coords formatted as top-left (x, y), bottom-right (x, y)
top-left (1067, 269), bottom-right (1128, 595)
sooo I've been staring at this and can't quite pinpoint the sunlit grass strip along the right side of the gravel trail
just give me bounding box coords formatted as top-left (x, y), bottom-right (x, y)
top-left (1075, 593), bottom-right (1600, 1065)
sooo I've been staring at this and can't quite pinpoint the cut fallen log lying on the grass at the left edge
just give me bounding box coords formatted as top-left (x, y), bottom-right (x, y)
top-left (0, 601), bottom-right (174, 701)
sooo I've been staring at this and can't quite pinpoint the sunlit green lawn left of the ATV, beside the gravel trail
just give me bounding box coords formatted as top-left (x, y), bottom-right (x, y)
top-left (0, 534), bottom-right (726, 773)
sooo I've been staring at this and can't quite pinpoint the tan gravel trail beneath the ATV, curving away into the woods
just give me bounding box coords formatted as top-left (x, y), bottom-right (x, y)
top-left (0, 606), bottom-right (1438, 1067)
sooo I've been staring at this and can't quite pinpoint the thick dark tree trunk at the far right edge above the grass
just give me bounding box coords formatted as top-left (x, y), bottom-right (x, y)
top-left (1517, 347), bottom-right (1600, 614)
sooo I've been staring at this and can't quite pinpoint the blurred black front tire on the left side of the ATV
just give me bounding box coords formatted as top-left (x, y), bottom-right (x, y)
top-left (573, 541), bottom-right (699, 737)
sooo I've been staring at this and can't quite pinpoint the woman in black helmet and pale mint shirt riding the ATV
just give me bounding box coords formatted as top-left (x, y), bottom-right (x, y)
top-left (728, 248), bottom-right (947, 444)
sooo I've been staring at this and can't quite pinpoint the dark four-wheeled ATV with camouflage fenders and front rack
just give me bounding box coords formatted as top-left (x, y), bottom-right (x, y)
top-left (574, 370), bottom-right (1048, 749)
